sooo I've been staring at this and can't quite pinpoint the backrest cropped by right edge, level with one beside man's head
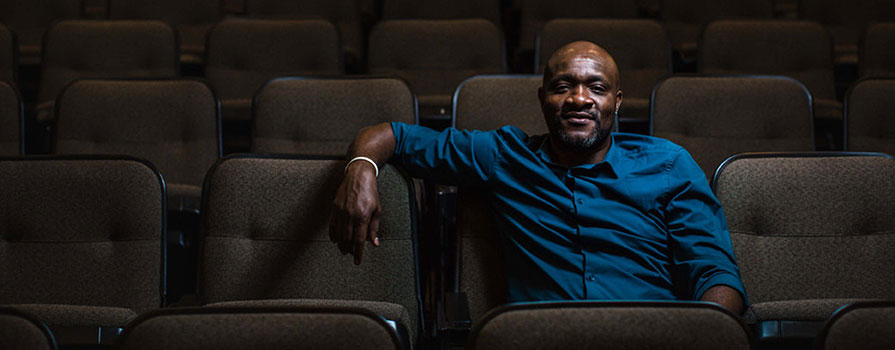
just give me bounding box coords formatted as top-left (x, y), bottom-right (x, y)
top-left (843, 79), bottom-right (895, 154)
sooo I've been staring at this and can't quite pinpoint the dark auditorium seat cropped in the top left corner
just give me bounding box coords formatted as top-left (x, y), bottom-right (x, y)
top-left (0, 0), bottom-right (81, 66)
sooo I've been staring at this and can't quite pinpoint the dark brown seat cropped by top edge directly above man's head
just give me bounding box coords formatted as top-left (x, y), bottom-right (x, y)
top-left (519, 0), bottom-right (637, 51)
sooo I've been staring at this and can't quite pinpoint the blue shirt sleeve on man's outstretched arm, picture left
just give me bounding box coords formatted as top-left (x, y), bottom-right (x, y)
top-left (392, 122), bottom-right (500, 186)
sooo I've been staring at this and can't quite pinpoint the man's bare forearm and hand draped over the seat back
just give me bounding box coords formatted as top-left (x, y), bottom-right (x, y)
top-left (329, 123), bottom-right (395, 264)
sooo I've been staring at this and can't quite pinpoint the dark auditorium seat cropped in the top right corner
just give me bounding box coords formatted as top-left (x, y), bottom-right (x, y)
top-left (799, 0), bottom-right (895, 65)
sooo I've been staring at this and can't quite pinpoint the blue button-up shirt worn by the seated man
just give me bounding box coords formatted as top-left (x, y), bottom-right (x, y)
top-left (392, 123), bottom-right (746, 302)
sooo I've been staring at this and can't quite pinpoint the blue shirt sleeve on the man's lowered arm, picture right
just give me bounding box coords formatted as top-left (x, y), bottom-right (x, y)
top-left (666, 149), bottom-right (748, 304)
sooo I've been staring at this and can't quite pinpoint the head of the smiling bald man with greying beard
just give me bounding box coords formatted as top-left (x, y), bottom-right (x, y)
top-left (538, 41), bottom-right (622, 151)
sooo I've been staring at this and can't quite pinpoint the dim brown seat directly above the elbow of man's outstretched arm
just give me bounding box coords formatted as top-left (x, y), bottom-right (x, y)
top-left (369, 19), bottom-right (506, 121)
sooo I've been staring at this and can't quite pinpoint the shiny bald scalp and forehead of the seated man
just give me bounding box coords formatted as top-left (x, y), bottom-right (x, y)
top-left (542, 41), bottom-right (621, 88)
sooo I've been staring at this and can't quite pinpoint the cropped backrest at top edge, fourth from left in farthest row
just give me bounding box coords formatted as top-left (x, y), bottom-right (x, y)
top-left (382, 0), bottom-right (501, 25)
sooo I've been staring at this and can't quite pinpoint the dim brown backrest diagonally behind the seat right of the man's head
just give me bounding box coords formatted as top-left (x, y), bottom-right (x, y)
top-left (698, 20), bottom-right (836, 100)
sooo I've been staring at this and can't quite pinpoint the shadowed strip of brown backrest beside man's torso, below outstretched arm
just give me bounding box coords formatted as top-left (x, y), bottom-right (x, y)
top-left (457, 188), bottom-right (507, 324)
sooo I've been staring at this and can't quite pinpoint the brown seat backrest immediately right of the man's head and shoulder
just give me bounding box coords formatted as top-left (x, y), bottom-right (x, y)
top-left (650, 76), bottom-right (814, 179)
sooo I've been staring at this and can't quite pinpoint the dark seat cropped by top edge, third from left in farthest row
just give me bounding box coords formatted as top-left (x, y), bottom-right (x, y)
top-left (242, 0), bottom-right (368, 73)
